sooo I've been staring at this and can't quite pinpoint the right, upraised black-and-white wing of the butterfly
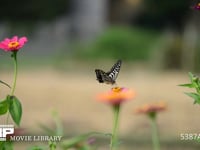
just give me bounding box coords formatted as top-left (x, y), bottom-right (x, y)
top-left (106, 60), bottom-right (122, 82)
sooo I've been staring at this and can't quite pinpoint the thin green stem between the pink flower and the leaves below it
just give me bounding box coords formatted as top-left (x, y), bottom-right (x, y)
top-left (10, 51), bottom-right (17, 96)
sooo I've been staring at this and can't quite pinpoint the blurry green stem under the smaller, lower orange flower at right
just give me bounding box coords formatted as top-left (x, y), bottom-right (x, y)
top-left (149, 112), bottom-right (160, 150)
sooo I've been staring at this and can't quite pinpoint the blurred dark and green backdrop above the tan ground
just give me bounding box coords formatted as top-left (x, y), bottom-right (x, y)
top-left (0, 0), bottom-right (199, 71)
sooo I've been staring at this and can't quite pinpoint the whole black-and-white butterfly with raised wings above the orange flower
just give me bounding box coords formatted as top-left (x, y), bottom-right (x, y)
top-left (95, 60), bottom-right (121, 84)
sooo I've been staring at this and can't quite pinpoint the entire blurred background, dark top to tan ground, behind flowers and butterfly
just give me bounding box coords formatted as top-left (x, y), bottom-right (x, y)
top-left (0, 0), bottom-right (200, 150)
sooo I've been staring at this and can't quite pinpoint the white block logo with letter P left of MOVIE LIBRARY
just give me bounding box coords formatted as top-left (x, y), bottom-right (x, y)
top-left (0, 125), bottom-right (14, 141)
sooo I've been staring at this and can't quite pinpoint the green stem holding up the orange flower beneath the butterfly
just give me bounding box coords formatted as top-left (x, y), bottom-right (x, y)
top-left (110, 104), bottom-right (120, 150)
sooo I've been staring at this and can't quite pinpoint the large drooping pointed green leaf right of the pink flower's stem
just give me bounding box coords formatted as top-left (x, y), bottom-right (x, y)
top-left (7, 96), bottom-right (22, 126)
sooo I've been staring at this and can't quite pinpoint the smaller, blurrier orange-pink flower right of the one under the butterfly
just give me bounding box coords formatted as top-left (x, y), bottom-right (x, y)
top-left (135, 102), bottom-right (167, 114)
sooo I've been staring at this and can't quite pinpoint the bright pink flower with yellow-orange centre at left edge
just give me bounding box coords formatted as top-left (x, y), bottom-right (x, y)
top-left (0, 36), bottom-right (28, 52)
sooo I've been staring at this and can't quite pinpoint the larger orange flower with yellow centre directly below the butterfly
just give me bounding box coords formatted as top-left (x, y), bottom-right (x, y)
top-left (97, 87), bottom-right (135, 105)
